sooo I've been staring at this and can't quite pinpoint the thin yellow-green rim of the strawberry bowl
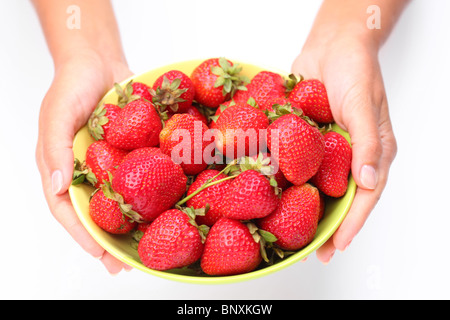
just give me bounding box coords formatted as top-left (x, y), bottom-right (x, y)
top-left (68, 59), bottom-right (357, 284)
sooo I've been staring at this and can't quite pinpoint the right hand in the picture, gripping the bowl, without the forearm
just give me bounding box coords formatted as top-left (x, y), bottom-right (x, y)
top-left (292, 35), bottom-right (397, 263)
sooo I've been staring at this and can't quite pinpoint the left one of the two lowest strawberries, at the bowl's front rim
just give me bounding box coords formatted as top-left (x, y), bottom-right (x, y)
top-left (138, 209), bottom-right (204, 271)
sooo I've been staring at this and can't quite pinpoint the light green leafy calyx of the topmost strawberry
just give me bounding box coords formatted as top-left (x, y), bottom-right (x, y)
top-left (211, 58), bottom-right (250, 97)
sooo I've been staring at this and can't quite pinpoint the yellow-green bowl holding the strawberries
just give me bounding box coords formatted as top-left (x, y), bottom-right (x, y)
top-left (69, 60), bottom-right (356, 284)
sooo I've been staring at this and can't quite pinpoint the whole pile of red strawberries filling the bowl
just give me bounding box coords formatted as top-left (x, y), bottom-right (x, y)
top-left (73, 58), bottom-right (351, 275)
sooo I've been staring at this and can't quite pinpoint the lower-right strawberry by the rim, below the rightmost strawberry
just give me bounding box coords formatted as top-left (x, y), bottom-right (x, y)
top-left (258, 184), bottom-right (320, 250)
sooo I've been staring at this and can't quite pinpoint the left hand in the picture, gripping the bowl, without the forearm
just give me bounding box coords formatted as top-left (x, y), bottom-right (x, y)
top-left (36, 50), bottom-right (132, 274)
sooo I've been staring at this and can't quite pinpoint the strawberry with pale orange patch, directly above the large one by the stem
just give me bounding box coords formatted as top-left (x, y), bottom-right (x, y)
top-left (159, 113), bottom-right (208, 175)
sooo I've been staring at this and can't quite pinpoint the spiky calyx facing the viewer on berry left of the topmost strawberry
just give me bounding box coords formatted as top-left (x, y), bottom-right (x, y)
top-left (149, 76), bottom-right (187, 112)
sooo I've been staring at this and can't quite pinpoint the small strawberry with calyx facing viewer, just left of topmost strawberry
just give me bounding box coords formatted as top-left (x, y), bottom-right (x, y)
top-left (150, 70), bottom-right (195, 113)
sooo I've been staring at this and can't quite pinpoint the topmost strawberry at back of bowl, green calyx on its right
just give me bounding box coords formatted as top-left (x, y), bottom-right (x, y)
top-left (190, 58), bottom-right (249, 108)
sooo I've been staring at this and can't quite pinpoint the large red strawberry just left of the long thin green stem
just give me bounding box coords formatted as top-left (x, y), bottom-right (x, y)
top-left (112, 152), bottom-right (187, 222)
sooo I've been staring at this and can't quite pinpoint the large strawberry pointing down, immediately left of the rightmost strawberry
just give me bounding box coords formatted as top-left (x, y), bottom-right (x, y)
top-left (267, 114), bottom-right (325, 185)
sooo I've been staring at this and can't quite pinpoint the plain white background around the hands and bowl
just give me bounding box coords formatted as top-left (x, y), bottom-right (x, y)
top-left (0, 0), bottom-right (450, 299)
